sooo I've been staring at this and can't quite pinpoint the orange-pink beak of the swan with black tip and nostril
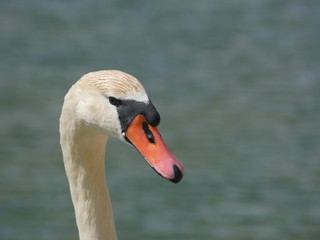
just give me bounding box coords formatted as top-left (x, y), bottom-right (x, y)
top-left (125, 114), bottom-right (184, 183)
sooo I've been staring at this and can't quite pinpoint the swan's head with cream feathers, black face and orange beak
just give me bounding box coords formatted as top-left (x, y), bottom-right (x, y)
top-left (69, 70), bottom-right (184, 183)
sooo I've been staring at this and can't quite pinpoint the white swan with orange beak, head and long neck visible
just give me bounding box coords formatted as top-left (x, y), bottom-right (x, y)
top-left (59, 70), bottom-right (184, 240)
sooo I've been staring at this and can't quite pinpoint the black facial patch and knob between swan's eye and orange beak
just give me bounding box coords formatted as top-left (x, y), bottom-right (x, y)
top-left (114, 97), bottom-right (160, 132)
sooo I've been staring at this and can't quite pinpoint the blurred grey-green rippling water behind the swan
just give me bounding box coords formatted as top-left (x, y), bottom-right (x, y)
top-left (0, 0), bottom-right (320, 240)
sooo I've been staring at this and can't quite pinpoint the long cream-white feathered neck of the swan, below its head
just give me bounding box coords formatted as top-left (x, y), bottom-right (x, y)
top-left (60, 119), bottom-right (117, 240)
